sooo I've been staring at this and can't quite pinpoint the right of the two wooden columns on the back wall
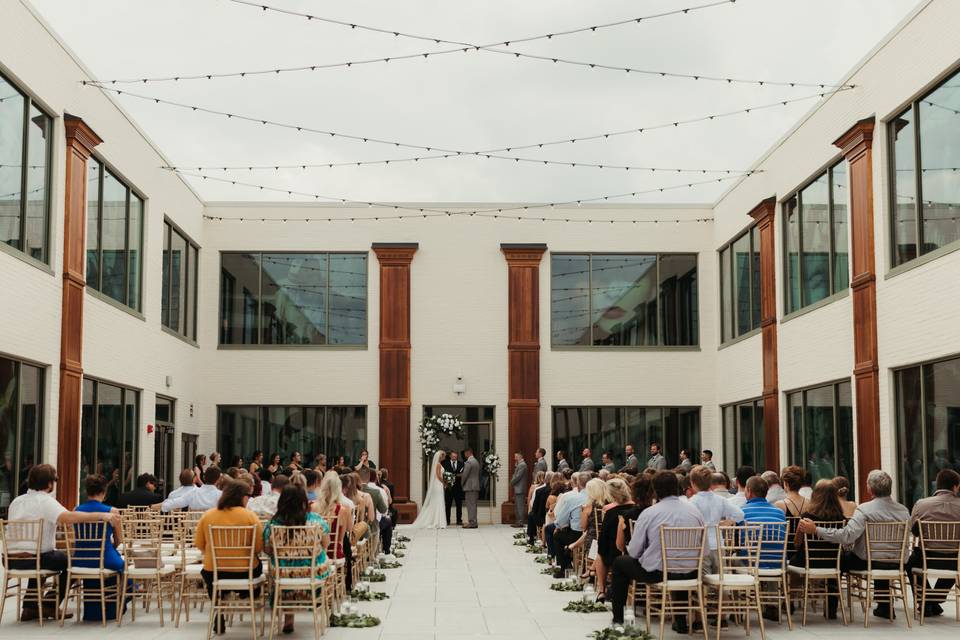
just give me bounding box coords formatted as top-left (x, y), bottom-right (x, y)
top-left (500, 244), bottom-right (547, 522)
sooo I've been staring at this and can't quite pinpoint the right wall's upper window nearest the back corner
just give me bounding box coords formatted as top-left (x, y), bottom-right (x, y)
top-left (720, 227), bottom-right (760, 342)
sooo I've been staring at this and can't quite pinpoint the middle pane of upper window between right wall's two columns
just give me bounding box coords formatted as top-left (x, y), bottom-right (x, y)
top-left (800, 173), bottom-right (830, 306)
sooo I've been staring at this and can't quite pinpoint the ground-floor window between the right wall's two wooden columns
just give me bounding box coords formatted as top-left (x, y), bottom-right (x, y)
top-left (787, 382), bottom-right (856, 499)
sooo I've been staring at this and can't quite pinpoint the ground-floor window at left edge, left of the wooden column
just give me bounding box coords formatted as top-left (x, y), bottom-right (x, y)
top-left (0, 357), bottom-right (43, 517)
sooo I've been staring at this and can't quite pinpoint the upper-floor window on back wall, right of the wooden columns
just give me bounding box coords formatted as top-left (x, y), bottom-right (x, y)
top-left (550, 253), bottom-right (699, 347)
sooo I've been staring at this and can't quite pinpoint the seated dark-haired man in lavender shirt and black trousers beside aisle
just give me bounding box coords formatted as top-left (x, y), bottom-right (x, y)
top-left (612, 471), bottom-right (703, 633)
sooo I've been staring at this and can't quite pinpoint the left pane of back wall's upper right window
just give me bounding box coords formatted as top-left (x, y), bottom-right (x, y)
top-left (550, 254), bottom-right (592, 345)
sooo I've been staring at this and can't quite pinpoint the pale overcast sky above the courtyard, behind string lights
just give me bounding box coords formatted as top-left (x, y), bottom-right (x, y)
top-left (33, 0), bottom-right (917, 202)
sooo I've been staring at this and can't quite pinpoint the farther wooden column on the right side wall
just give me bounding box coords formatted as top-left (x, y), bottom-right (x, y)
top-left (750, 197), bottom-right (780, 470)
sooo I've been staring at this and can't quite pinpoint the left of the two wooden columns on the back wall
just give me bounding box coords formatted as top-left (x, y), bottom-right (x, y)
top-left (373, 242), bottom-right (418, 523)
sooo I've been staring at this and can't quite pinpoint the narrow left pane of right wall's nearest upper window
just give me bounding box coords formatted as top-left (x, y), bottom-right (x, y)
top-left (889, 109), bottom-right (917, 265)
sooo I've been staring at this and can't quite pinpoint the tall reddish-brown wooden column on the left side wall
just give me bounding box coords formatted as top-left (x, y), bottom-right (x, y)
top-left (57, 115), bottom-right (102, 509)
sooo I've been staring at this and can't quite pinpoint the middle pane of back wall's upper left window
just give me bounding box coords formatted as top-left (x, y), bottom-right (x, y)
top-left (261, 253), bottom-right (327, 344)
